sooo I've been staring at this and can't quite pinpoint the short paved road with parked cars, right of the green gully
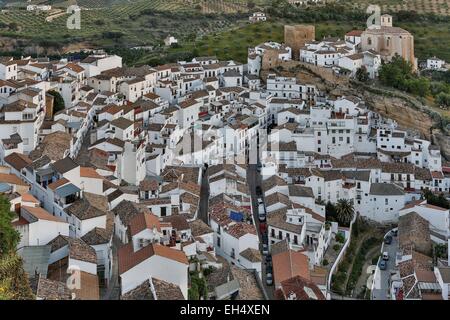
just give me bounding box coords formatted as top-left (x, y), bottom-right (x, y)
top-left (372, 230), bottom-right (398, 300)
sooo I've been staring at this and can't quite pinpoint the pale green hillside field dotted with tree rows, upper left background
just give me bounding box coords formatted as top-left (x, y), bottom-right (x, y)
top-left (0, 0), bottom-right (246, 45)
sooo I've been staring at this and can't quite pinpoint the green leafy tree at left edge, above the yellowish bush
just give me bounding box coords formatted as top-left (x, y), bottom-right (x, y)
top-left (0, 195), bottom-right (20, 256)
